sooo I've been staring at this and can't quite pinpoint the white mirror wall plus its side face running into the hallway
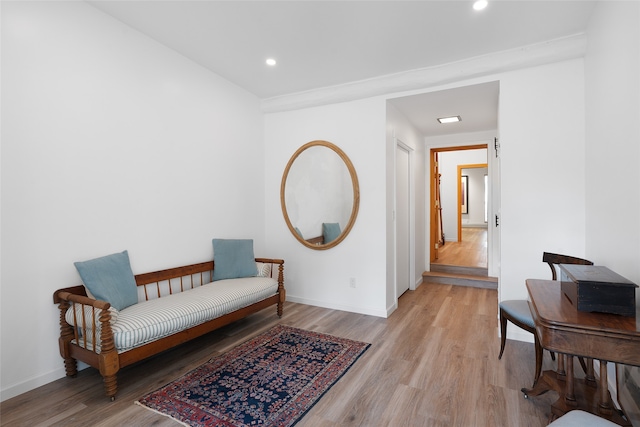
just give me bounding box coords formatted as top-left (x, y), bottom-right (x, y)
top-left (265, 98), bottom-right (426, 317)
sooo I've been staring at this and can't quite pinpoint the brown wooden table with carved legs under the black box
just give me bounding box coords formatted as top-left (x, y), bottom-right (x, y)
top-left (522, 279), bottom-right (640, 425)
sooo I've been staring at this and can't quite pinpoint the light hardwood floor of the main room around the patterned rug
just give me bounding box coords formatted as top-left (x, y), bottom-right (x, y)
top-left (0, 283), bottom-right (557, 427)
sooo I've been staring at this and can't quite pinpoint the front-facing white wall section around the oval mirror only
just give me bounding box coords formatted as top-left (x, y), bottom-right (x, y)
top-left (264, 99), bottom-right (387, 316)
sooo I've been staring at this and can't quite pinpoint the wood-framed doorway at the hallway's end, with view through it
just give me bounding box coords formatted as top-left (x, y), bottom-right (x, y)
top-left (429, 144), bottom-right (490, 271)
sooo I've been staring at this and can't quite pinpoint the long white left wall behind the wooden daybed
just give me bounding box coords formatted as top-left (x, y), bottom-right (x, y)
top-left (1, 2), bottom-right (264, 399)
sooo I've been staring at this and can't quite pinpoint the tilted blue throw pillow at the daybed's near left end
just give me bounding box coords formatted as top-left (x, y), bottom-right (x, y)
top-left (73, 251), bottom-right (138, 310)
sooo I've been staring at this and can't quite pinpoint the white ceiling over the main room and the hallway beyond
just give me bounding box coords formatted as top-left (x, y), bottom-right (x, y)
top-left (88, 0), bottom-right (594, 135)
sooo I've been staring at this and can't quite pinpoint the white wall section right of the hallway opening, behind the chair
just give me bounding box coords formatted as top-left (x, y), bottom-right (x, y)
top-left (499, 59), bottom-right (585, 300)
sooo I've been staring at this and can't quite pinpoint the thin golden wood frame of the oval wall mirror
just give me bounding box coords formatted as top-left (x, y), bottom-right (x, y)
top-left (280, 140), bottom-right (360, 251)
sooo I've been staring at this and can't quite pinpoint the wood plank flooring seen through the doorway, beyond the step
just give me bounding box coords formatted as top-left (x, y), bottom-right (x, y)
top-left (432, 227), bottom-right (487, 268)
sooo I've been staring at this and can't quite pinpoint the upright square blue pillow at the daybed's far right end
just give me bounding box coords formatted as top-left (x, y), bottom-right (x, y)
top-left (213, 239), bottom-right (258, 281)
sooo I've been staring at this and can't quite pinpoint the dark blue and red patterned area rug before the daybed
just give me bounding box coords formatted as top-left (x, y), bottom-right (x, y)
top-left (136, 325), bottom-right (370, 427)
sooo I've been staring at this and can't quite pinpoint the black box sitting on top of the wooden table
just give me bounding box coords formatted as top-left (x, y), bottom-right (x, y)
top-left (560, 264), bottom-right (638, 316)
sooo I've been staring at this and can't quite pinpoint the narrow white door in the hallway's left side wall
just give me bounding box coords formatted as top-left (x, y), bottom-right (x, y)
top-left (395, 141), bottom-right (411, 299)
